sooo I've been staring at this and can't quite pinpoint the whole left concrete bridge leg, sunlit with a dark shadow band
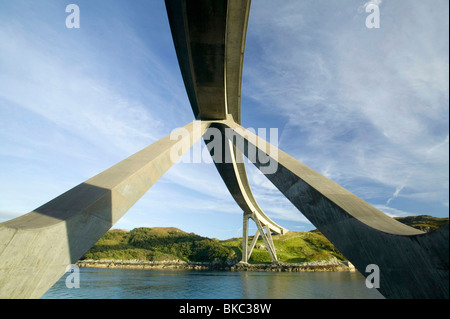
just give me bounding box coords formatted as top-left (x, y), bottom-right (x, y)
top-left (0, 121), bottom-right (209, 298)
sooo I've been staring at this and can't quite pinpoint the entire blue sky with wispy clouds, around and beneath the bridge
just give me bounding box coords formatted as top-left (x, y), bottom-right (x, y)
top-left (0, 0), bottom-right (449, 239)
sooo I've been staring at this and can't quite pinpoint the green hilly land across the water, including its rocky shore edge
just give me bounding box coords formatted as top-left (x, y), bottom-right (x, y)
top-left (77, 215), bottom-right (448, 272)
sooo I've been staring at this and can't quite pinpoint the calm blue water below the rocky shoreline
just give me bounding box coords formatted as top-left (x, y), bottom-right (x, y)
top-left (43, 268), bottom-right (383, 299)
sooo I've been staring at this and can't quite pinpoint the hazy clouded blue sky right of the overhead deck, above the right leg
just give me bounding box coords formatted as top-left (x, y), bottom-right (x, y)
top-left (243, 1), bottom-right (449, 218)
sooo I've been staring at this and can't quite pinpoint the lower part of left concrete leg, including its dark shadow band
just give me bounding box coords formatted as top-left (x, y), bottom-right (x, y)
top-left (0, 183), bottom-right (113, 298)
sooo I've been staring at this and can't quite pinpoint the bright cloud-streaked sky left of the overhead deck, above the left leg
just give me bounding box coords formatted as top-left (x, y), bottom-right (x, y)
top-left (0, 1), bottom-right (197, 230)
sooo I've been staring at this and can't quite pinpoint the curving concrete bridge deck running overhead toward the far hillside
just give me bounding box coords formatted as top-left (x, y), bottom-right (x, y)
top-left (166, 0), bottom-right (287, 261)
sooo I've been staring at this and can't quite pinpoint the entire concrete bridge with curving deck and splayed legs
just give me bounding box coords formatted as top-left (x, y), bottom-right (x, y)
top-left (0, 0), bottom-right (449, 298)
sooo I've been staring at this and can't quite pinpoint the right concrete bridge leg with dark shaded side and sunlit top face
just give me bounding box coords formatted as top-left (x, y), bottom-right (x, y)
top-left (225, 123), bottom-right (449, 299)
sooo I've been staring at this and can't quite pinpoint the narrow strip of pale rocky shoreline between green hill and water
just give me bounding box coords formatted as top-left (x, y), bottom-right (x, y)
top-left (77, 260), bottom-right (355, 272)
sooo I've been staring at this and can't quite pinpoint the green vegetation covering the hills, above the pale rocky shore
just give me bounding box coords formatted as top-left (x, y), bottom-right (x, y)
top-left (81, 216), bottom-right (448, 264)
